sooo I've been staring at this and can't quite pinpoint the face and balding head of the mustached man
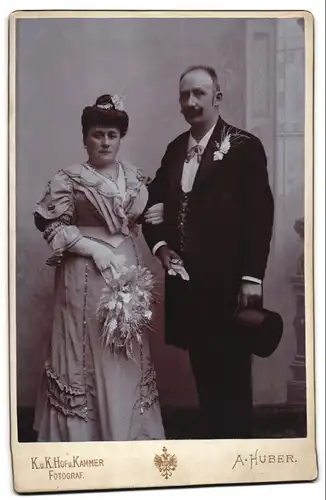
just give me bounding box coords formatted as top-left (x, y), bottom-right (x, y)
top-left (179, 69), bottom-right (217, 125)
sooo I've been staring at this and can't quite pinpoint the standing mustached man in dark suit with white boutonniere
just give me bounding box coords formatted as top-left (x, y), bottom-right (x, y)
top-left (143, 66), bottom-right (274, 438)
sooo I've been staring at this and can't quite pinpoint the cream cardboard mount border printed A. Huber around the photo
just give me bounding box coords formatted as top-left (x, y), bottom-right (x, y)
top-left (9, 10), bottom-right (317, 493)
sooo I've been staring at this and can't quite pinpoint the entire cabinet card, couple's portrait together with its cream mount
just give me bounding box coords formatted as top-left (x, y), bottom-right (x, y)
top-left (10, 11), bottom-right (316, 492)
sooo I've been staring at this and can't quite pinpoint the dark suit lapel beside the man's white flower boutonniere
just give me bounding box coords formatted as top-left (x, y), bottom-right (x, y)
top-left (192, 117), bottom-right (227, 192)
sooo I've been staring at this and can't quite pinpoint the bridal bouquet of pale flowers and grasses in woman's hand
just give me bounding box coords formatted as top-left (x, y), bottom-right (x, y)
top-left (96, 266), bottom-right (154, 359)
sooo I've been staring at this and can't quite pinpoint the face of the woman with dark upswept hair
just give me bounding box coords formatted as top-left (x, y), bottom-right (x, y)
top-left (85, 126), bottom-right (121, 168)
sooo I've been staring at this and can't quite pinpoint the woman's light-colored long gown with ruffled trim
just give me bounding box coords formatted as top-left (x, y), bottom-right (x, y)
top-left (34, 162), bottom-right (165, 441)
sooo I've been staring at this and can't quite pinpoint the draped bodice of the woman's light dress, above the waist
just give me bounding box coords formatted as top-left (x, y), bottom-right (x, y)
top-left (34, 162), bottom-right (148, 236)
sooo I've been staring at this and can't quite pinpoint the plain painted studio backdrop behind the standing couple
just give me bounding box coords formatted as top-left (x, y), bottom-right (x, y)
top-left (16, 19), bottom-right (305, 438)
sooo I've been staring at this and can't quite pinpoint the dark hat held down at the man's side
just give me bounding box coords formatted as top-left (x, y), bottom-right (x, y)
top-left (234, 307), bottom-right (283, 358)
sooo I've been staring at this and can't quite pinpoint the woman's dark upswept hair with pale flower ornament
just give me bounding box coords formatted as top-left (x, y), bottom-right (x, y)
top-left (81, 94), bottom-right (129, 142)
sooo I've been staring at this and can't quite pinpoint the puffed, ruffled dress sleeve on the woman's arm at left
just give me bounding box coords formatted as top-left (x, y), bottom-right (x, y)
top-left (34, 170), bottom-right (82, 266)
